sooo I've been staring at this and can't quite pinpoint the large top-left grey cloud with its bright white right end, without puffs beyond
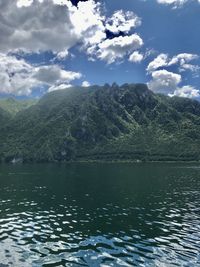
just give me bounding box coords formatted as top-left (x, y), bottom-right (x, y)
top-left (0, 0), bottom-right (106, 56)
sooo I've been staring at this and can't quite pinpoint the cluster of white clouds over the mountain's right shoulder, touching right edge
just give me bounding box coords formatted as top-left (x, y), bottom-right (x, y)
top-left (146, 53), bottom-right (199, 98)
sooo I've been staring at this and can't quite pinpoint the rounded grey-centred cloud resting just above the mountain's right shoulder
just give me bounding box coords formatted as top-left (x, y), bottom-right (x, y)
top-left (148, 70), bottom-right (181, 94)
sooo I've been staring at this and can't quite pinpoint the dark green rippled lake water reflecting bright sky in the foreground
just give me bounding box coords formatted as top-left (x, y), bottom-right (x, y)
top-left (0, 163), bottom-right (200, 267)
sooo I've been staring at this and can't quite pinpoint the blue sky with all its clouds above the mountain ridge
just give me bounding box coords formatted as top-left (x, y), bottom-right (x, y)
top-left (0, 0), bottom-right (200, 98)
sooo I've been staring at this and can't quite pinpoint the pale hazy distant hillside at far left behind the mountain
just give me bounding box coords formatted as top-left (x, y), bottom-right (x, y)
top-left (0, 97), bottom-right (38, 115)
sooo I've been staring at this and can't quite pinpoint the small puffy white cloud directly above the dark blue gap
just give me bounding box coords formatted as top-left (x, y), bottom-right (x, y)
top-left (106, 10), bottom-right (141, 33)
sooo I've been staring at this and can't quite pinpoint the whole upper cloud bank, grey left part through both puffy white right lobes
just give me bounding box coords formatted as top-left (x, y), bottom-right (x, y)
top-left (0, 0), bottom-right (142, 62)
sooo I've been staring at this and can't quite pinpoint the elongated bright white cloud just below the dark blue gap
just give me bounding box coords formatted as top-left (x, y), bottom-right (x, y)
top-left (96, 34), bottom-right (143, 64)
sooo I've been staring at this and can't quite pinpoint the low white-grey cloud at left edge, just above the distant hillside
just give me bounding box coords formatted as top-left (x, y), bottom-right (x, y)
top-left (0, 53), bottom-right (81, 95)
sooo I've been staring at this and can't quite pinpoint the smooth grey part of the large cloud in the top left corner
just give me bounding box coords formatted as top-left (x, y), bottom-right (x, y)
top-left (0, 0), bottom-right (78, 53)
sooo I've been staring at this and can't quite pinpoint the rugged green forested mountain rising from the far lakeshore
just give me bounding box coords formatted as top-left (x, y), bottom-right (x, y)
top-left (0, 84), bottom-right (200, 162)
